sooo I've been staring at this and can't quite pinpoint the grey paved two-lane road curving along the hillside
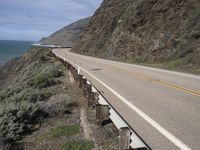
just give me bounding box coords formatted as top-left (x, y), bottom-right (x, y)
top-left (53, 49), bottom-right (200, 150)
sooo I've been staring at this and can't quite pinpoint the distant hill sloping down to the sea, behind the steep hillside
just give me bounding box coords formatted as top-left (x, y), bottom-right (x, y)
top-left (39, 18), bottom-right (90, 47)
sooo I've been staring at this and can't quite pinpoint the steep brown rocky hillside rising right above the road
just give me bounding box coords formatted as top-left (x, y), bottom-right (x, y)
top-left (73, 0), bottom-right (200, 71)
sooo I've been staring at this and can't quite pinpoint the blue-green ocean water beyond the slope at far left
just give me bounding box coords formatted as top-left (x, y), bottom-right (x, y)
top-left (0, 40), bottom-right (34, 65)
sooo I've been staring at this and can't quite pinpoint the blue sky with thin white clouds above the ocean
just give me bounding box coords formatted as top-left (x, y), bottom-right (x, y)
top-left (0, 0), bottom-right (102, 41)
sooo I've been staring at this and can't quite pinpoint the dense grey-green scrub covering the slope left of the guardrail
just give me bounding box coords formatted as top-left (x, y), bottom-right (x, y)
top-left (0, 48), bottom-right (69, 141)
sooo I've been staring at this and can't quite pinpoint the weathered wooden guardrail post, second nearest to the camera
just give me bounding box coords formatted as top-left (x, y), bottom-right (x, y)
top-left (96, 104), bottom-right (110, 124)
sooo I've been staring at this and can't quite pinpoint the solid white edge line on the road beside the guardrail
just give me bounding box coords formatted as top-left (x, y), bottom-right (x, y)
top-left (53, 50), bottom-right (192, 150)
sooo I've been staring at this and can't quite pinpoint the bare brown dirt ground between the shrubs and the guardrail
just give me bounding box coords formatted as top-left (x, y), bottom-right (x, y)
top-left (9, 73), bottom-right (118, 150)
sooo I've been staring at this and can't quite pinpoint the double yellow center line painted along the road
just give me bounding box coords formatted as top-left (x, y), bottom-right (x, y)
top-left (106, 65), bottom-right (200, 97)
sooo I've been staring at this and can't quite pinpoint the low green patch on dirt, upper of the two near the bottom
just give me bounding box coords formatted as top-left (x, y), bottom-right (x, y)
top-left (50, 124), bottom-right (80, 138)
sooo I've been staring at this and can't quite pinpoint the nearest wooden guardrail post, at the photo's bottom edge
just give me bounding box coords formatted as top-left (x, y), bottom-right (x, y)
top-left (119, 127), bottom-right (131, 150)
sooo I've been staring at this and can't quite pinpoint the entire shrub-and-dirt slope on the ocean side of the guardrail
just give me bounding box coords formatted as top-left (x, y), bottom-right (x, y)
top-left (0, 47), bottom-right (118, 150)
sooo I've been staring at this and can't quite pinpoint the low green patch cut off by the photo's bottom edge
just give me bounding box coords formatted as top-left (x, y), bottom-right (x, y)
top-left (61, 140), bottom-right (94, 150)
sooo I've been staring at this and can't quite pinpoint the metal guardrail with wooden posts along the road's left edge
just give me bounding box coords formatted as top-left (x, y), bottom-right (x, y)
top-left (53, 51), bottom-right (150, 150)
